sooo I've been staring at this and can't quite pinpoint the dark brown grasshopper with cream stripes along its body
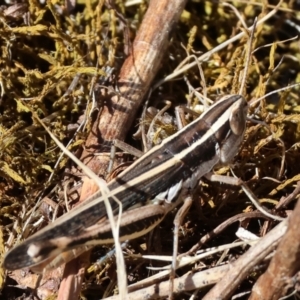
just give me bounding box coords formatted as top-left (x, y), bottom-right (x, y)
top-left (3, 95), bottom-right (248, 270)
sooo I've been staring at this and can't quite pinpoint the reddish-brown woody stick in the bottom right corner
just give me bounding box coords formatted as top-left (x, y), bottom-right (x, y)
top-left (249, 201), bottom-right (300, 300)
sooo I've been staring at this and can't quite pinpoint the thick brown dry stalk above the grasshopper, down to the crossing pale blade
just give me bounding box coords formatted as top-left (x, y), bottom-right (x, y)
top-left (81, 0), bottom-right (186, 174)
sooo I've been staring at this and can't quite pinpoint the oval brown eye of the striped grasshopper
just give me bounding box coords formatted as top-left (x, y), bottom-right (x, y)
top-left (229, 97), bottom-right (247, 135)
